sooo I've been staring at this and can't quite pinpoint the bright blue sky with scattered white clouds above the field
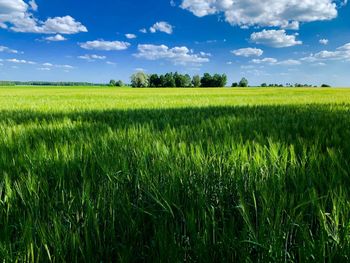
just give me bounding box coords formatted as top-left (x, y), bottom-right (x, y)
top-left (0, 0), bottom-right (350, 86)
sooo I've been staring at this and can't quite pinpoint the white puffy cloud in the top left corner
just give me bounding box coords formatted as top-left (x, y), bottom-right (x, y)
top-left (0, 0), bottom-right (87, 34)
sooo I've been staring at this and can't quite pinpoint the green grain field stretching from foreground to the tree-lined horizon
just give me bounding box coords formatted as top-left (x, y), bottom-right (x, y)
top-left (0, 87), bottom-right (350, 262)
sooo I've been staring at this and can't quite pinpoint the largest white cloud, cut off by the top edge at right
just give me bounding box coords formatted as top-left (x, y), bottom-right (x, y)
top-left (181, 0), bottom-right (346, 29)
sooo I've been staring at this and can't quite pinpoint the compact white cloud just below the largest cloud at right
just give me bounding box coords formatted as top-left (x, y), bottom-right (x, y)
top-left (250, 29), bottom-right (303, 48)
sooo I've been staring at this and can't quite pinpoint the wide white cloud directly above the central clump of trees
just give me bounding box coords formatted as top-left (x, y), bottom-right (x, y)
top-left (134, 44), bottom-right (209, 65)
